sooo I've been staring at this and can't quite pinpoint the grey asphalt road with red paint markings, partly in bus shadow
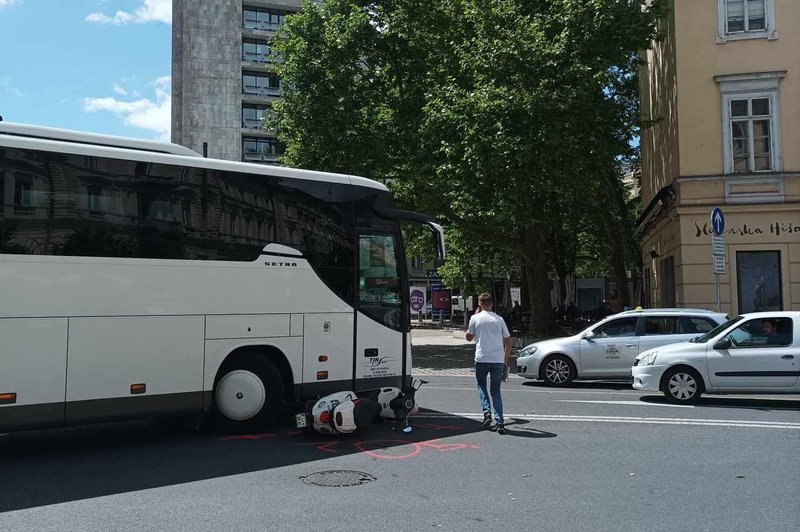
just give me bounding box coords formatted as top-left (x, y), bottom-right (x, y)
top-left (0, 347), bottom-right (800, 532)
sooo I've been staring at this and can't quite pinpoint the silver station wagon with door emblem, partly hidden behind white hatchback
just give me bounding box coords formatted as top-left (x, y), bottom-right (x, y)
top-left (517, 308), bottom-right (727, 386)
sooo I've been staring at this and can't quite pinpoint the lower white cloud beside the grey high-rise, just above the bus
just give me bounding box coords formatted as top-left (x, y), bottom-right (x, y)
top-left (82, 76), bottom-right (172, 142)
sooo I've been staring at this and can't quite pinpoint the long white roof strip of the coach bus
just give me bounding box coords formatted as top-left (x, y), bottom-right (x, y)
top-left (0, 122), bottom-right (389, 192)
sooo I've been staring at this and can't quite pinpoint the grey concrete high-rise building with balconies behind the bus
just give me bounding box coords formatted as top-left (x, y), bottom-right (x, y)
top-left (172, 0), bottom-right (302, 164)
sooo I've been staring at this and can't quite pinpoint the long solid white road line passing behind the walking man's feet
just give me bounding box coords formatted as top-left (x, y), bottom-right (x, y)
top-left (414, 412), bottom-right (800, 430)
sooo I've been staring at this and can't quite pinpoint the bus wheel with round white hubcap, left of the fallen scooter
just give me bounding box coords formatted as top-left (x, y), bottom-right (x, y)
top-left (214, 355), bottom-right (284, 432)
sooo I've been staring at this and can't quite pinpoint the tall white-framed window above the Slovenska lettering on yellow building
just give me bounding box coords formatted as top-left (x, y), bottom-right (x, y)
top-left (715, 71), bottom-right (786, 174)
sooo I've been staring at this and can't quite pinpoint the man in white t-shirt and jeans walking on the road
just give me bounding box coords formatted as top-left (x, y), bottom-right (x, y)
top-left (467, 294), bottom-right (511, 434)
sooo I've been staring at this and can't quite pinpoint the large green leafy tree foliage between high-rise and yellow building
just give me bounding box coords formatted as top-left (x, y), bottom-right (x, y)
top-left (272, 0), bottom-right (664, 332)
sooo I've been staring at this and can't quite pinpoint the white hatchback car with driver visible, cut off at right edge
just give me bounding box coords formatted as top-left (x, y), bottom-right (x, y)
top-left (631, 312), bottom-right (800, 403)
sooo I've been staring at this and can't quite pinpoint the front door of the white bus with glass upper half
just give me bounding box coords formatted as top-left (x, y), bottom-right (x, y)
top-left (353, 230), bottom-right (411, 391)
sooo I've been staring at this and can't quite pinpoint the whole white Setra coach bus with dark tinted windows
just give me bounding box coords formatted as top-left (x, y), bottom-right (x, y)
top-left (0, 122), bottom-right (444, 432)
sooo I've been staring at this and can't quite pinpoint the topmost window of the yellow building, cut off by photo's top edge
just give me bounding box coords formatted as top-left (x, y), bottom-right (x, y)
top-left (717, 0), bottom-right (778, 44)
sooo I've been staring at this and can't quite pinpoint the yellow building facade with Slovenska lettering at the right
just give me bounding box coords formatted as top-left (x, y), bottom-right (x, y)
top-left (637, 0), bottom-right (800, 315)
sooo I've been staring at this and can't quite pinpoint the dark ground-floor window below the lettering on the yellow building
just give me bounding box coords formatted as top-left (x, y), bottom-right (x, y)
top-left (736, 251), bottom-right (783, 314)
